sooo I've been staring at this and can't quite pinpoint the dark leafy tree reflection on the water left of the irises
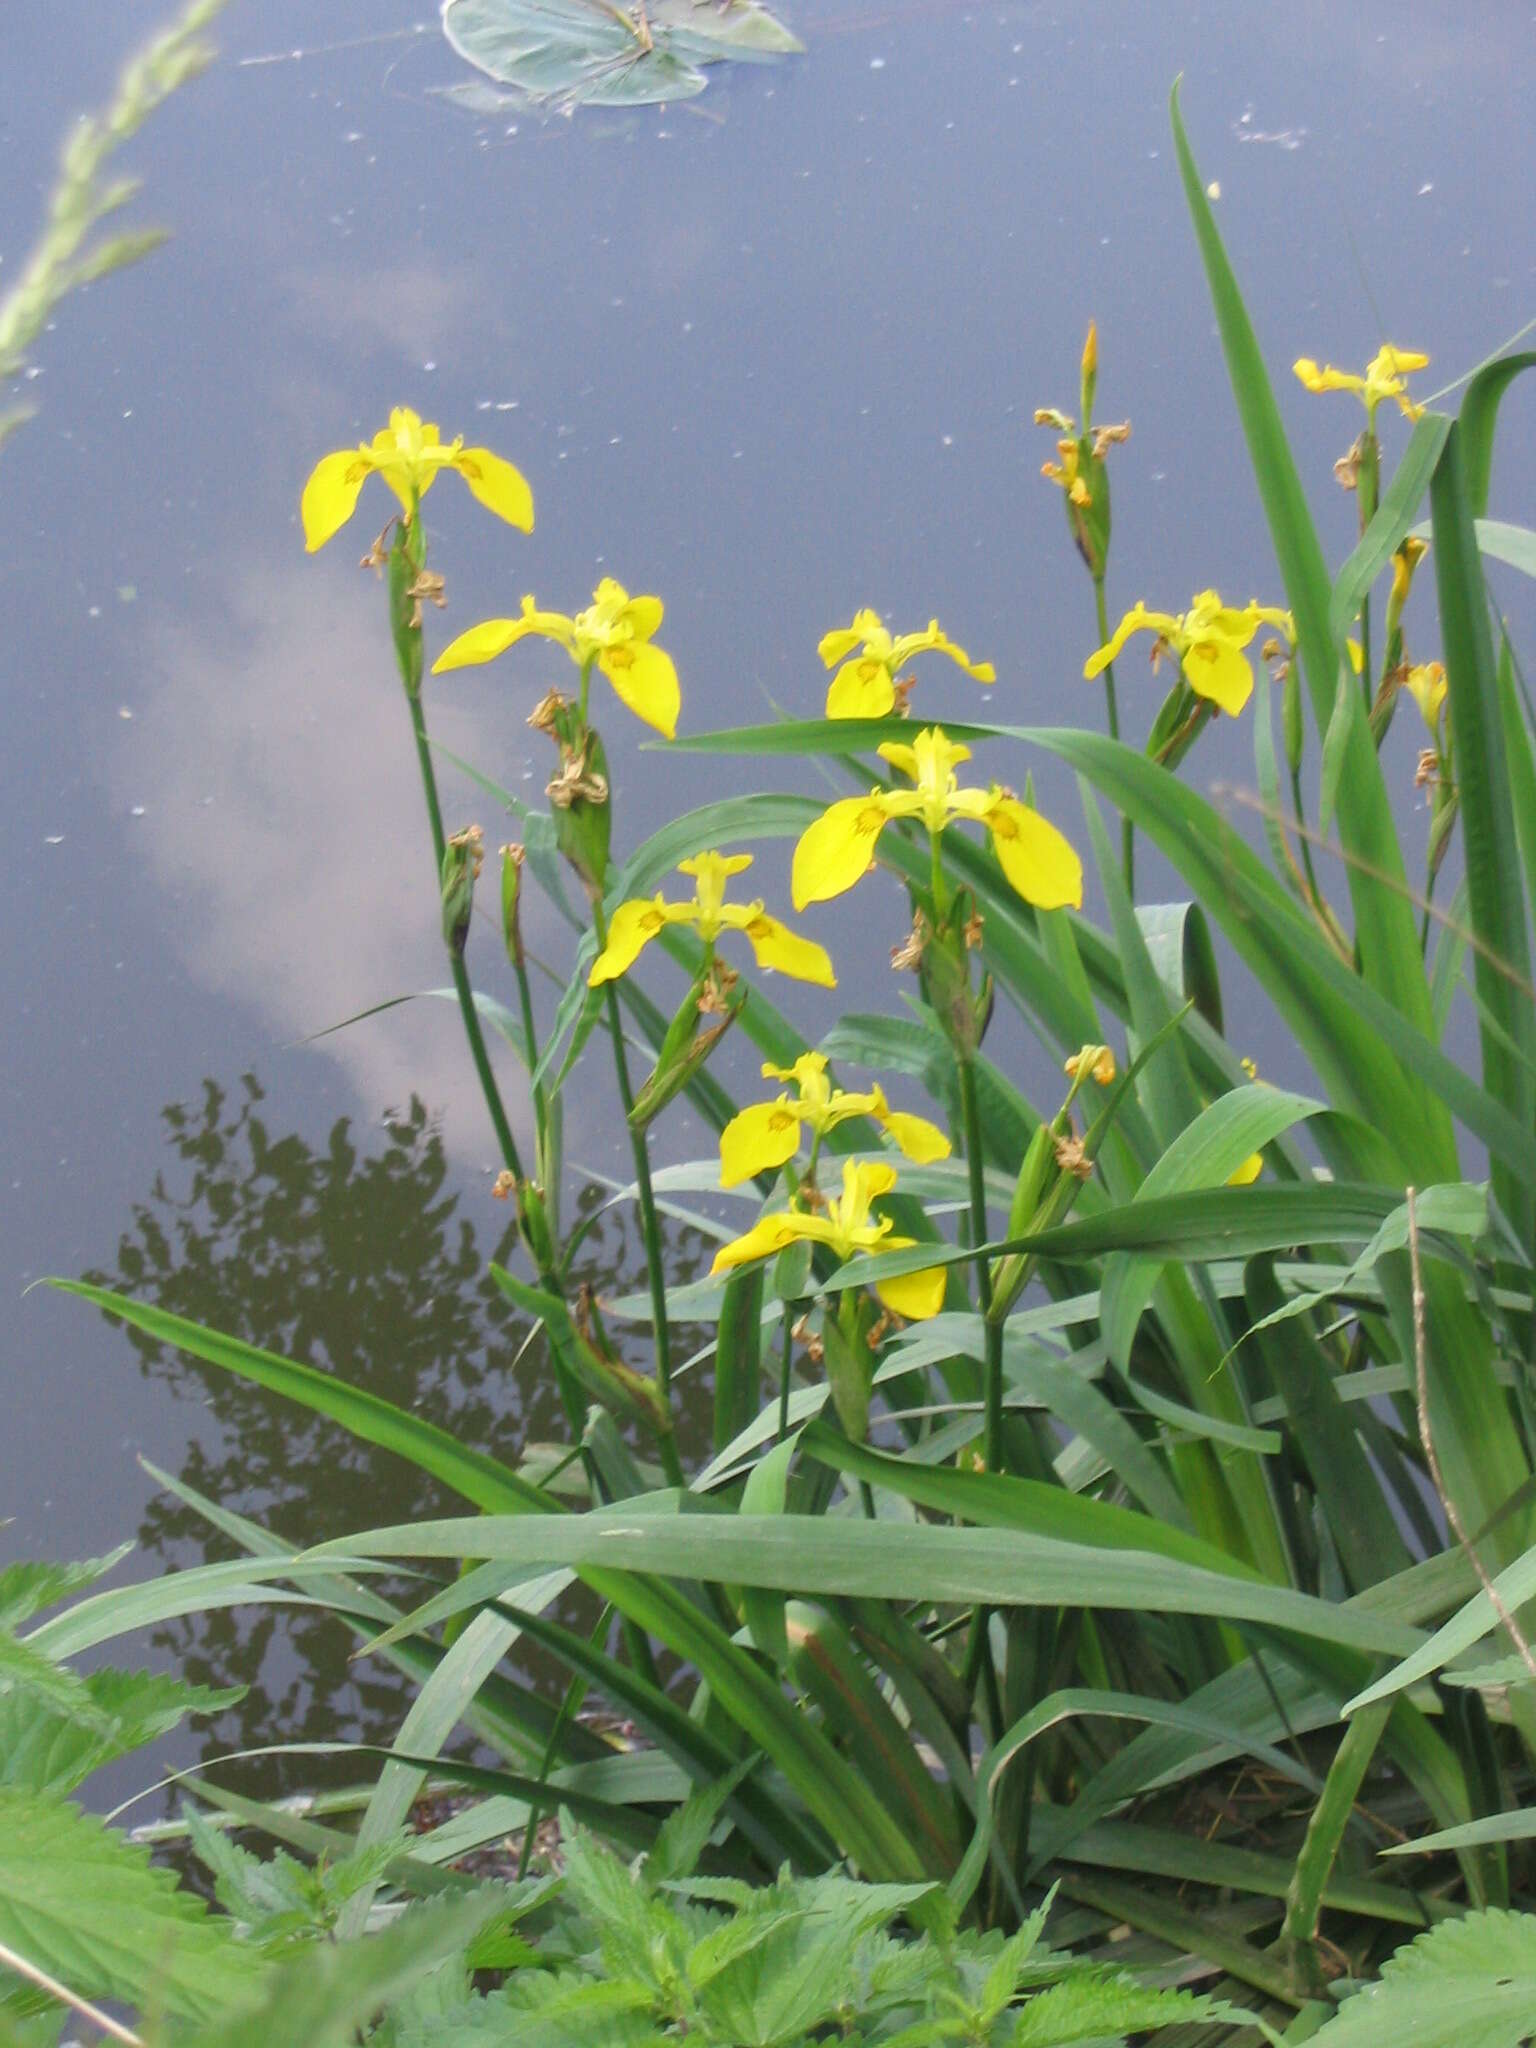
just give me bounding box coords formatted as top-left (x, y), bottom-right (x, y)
top-left (88, 1073), bottom-right (720, 1792)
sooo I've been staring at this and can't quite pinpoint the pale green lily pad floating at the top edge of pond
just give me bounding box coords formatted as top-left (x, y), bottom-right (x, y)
top-left (442, 0), bottom-right (805, 109)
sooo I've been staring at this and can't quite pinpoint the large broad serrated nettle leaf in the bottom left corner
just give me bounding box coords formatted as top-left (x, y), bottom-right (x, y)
top-left (0, 1788), bottom-right (262, 2019)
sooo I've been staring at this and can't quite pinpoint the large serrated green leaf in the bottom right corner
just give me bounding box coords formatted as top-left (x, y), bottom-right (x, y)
top-left (1313, 1911), bottom-right (1536, 2048)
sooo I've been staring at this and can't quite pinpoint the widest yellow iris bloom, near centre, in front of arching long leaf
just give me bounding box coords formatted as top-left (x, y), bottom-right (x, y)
top-left (791, 725), bottom-right (1083, 909)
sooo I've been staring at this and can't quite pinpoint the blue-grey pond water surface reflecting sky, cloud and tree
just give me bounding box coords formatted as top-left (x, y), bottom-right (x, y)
top-left (0, 0), bottom-right (1536, 1785)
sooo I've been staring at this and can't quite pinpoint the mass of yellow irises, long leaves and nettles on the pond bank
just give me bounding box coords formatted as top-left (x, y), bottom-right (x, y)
top-left (18, 64), bottom-right (1536, 2048)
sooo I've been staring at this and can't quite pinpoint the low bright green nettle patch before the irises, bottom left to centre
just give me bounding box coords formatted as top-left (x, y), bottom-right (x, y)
top-left (0, 1605), bottom-right (1277, 2048)
